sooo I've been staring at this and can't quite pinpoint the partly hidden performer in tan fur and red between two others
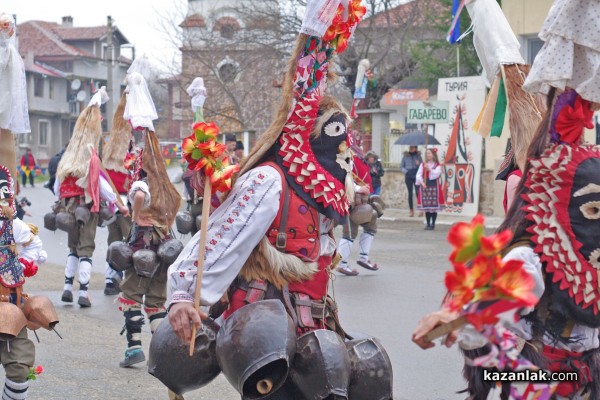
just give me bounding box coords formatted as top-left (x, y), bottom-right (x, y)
top-left (102, 93), bottom-right (134, 295)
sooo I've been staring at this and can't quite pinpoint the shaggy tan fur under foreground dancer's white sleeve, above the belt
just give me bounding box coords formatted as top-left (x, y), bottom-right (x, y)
top-left (240, 237), bottom-right (318, 290)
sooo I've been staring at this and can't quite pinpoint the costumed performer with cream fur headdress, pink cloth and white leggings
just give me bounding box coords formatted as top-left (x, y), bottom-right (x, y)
top-left (48, 88), bottom-right (122, 307)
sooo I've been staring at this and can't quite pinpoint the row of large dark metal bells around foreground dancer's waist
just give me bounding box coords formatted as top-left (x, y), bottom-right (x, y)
top-left (148, 300), bottom-right (393, 400)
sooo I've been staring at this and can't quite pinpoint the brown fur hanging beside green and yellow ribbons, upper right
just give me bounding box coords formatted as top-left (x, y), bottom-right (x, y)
top-left (503, 64), bottom-right (546, 170)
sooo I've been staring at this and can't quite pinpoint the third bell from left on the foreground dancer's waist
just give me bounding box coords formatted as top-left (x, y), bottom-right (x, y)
top-left (290, 329), bottom-right (354, 400)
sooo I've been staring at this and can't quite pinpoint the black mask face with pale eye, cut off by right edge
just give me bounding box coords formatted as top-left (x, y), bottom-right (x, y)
top-left (569, 158), bottom-right (600, 269)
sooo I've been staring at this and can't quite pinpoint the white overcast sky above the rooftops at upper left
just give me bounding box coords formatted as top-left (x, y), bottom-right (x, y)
top-left (5, 0), bottom-right (187, 71)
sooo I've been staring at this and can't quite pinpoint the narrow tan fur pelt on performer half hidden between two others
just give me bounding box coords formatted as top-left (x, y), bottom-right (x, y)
top-left (102, 93), bottom-right (131, 173)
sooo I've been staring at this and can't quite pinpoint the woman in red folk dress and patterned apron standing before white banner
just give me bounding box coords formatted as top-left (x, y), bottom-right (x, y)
top-left (416, 149), bottom-right (444, 231)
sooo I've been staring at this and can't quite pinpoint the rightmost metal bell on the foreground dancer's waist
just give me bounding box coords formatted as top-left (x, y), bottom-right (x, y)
top-left (346, 335), bottom-right (394, 400)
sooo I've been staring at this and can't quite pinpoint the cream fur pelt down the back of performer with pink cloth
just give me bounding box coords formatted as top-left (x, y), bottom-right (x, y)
top-left (56, 105), bottom-right (102, 181)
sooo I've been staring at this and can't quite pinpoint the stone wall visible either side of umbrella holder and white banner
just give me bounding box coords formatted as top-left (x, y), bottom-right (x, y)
top-left (381, 169), bottom-right (494, 215)
